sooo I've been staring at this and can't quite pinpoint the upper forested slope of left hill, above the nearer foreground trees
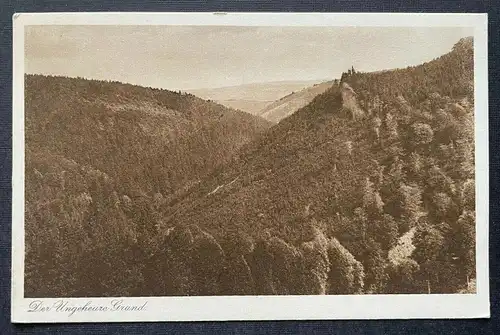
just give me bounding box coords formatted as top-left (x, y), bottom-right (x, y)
top-left (26, 76), bottom-right (270, 194)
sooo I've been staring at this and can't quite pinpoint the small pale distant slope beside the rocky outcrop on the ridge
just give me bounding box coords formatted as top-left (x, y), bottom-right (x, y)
top-left (257, 81), bottom-right (334, 122)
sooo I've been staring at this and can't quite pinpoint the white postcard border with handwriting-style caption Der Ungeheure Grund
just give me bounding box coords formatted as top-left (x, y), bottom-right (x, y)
top-left (11, 13), bottom-right (490, 323)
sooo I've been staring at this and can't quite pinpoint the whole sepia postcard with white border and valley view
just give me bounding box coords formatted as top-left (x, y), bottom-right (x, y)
top-left (12, 13), bottom-right (490, 323)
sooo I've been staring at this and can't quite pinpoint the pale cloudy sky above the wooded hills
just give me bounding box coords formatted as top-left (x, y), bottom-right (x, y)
top-left (25, 26), bottom-right (473, 90)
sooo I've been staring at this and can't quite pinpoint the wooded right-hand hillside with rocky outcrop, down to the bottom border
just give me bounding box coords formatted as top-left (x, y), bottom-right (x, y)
top-left (150, 39), bottom-right (474, 295)
